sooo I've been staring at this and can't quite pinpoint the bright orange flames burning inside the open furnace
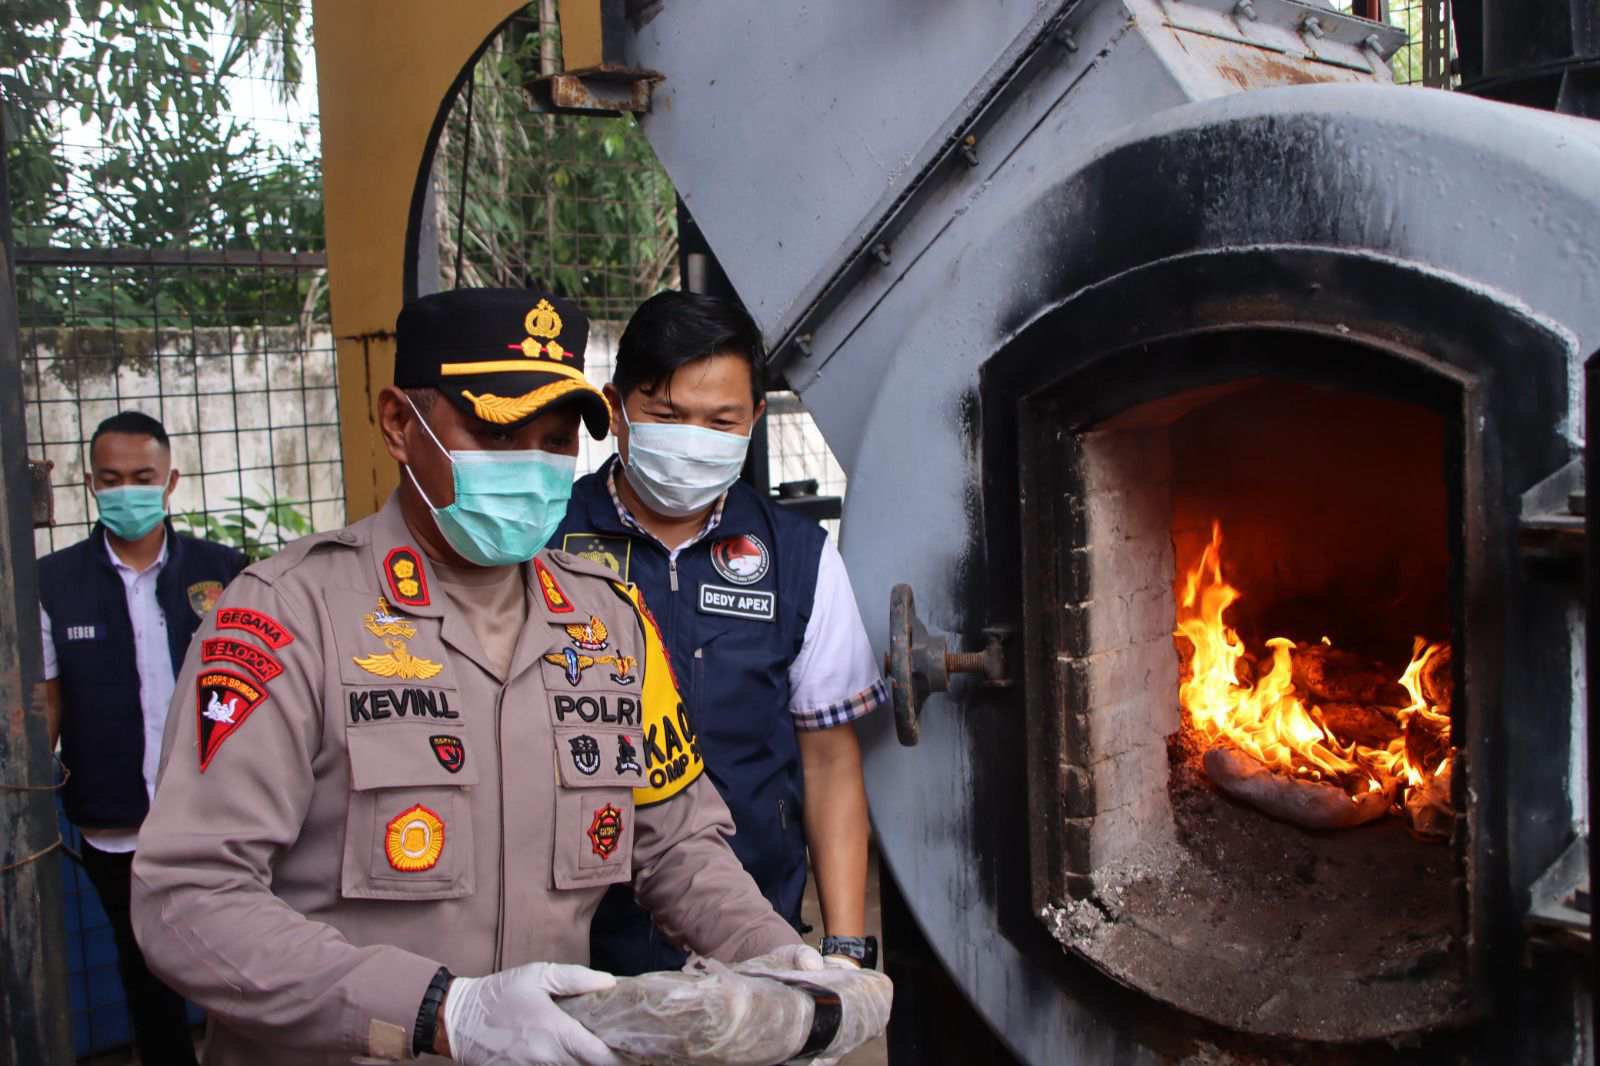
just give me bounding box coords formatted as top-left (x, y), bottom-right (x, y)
top-left (1174, 522), bottom-right (1450, 802)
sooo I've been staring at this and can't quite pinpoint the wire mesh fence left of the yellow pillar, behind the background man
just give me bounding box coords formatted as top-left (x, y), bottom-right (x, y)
top-left (0, 0), bottom-right (344, 554)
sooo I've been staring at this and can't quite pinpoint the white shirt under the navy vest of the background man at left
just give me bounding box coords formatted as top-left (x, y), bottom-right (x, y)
top-left (38, 535), bottom-right (176, 852)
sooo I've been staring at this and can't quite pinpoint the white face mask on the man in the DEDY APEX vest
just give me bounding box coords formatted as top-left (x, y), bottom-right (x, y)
top-left (622, 408), bottom-right (750, 519)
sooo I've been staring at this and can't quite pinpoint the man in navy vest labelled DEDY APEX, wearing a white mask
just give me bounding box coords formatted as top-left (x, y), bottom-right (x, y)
top-left (550, 291), bottom-right (886, 975)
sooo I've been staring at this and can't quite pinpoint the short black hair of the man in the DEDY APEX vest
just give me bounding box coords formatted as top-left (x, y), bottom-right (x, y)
top-left (611, 290), bottom-right (766, 403)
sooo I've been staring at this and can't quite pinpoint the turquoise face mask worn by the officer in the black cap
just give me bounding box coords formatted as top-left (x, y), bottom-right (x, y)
top-left (406, 397), bottom-right (578, 567)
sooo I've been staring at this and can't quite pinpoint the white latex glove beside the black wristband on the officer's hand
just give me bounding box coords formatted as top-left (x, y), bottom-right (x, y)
top-left (445, 962), bottom-right (624, 1066)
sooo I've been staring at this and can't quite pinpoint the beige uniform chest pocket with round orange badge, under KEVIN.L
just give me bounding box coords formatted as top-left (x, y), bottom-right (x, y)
top-left (341, 722), bottom-right (478, 900)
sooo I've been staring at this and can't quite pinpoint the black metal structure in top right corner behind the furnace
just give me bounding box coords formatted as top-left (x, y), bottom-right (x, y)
top-left (1454, 0), bottom-right (1600, 118)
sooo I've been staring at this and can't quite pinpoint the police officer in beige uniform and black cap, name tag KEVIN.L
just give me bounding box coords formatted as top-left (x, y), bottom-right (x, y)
top-left (133, 290), bottom-right (821, 1064)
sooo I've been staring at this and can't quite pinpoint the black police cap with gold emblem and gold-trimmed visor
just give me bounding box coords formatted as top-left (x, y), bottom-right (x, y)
top-left (395, 288), bottom-right (611, 440)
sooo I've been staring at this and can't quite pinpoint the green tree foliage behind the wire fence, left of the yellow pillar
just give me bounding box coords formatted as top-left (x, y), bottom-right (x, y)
top-left (0, 0), bottom-right (323, 325)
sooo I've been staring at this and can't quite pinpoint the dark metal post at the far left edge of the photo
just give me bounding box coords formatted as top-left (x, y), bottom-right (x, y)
top-left (0, 161), bottom-right (72, 1066)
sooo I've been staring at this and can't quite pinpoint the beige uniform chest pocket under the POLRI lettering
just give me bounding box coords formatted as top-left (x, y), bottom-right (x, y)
top-left (550, 725), bottom-right (643, 888)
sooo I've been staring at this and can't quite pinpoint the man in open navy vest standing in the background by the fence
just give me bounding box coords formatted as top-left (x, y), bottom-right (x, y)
top-left (38, 411), bottom-right (246, 1066)
